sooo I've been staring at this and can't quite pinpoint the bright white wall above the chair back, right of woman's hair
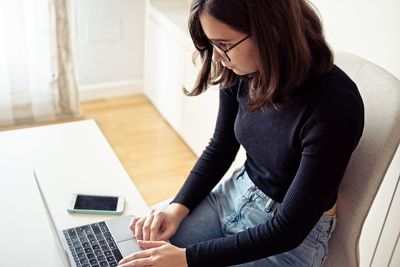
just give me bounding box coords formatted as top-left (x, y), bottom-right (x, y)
top-left (311, 0), bottom-right (400, 79)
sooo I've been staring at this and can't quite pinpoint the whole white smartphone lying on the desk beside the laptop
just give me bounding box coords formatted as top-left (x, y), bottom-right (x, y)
top-left (67, 194), bottom-right (125, 215)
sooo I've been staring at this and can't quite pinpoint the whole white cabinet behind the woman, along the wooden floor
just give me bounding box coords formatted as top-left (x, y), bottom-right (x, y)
top-left (144, 0), bottom-right (218, 156)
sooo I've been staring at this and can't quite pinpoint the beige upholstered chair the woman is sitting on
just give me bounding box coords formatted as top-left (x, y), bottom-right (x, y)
top-left (324, 52), bottom-right (400, 267)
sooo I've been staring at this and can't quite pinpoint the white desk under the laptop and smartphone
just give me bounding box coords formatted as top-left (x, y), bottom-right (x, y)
top-left (0, 120), bottom-right (148, 267)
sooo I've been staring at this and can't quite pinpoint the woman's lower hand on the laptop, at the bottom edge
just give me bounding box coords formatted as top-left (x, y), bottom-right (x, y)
top-left (118, 240), bottom-right (188, 267)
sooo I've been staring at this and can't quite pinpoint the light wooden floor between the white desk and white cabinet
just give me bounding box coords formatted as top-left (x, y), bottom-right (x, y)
top-left (81, 95), bottom-right (196, 205)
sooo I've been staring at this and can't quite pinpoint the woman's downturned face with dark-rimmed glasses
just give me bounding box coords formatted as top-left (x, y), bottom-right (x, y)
top-left (200, 12), bottom-right (259, 75)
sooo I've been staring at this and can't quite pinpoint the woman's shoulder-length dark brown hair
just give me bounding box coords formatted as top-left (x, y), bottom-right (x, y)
top-left (186, 0), bottom-right (333, 111)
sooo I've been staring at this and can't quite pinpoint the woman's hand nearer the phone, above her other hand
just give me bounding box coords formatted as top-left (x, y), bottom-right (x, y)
top-left (129, 203), bottom-right (189, 241)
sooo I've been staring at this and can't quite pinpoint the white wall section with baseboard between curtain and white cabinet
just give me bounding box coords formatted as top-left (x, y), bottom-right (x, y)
top-left (72, 0), bottom-right (145, 100)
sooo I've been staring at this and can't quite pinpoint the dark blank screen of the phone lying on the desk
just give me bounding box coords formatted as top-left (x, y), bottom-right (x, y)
top-left (74, 195), bottom-right (118, 211)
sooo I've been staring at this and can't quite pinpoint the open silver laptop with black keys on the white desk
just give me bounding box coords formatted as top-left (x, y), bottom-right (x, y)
top-left (33, 171), bottom-right (143, 267)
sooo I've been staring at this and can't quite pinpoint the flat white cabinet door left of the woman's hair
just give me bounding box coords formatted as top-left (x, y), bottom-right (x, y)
top-left (144, 11), bottom-right (184, 131)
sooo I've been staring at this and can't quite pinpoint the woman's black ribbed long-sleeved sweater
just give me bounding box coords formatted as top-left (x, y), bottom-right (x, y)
top-left (173, 66), bottom-right (364, 266)
